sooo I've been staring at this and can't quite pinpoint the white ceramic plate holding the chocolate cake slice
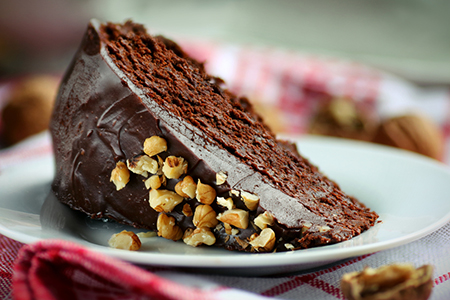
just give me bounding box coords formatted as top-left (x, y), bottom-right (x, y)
top-left (0, 136), bottom-right (450, 276)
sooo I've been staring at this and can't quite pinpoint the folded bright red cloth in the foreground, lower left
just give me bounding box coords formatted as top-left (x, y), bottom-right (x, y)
top-left (13, 240), bottom-right (224, 300)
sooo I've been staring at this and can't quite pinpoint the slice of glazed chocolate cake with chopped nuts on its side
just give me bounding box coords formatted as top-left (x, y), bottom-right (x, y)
top-left (51, 20), bottom-right (378, 252)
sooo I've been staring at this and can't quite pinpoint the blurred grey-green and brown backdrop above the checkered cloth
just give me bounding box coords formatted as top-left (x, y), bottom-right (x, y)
top-left (0, 0), bottom-right (450, 84)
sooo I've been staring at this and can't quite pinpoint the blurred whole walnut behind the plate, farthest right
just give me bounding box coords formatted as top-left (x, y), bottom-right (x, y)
top-left (373, 114), bottom-right (444, 160)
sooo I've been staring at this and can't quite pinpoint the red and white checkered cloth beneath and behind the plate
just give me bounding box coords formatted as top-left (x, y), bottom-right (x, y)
top-left (0, 42), bottom-right (450, 300)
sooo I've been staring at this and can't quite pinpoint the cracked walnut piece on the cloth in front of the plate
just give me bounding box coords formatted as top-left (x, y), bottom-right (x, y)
top-left (341, 264), bottom-right (433, 300)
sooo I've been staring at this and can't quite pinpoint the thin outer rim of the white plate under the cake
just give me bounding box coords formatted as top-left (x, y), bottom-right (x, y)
top-left (0, 135), bottom-right (450, 268)
